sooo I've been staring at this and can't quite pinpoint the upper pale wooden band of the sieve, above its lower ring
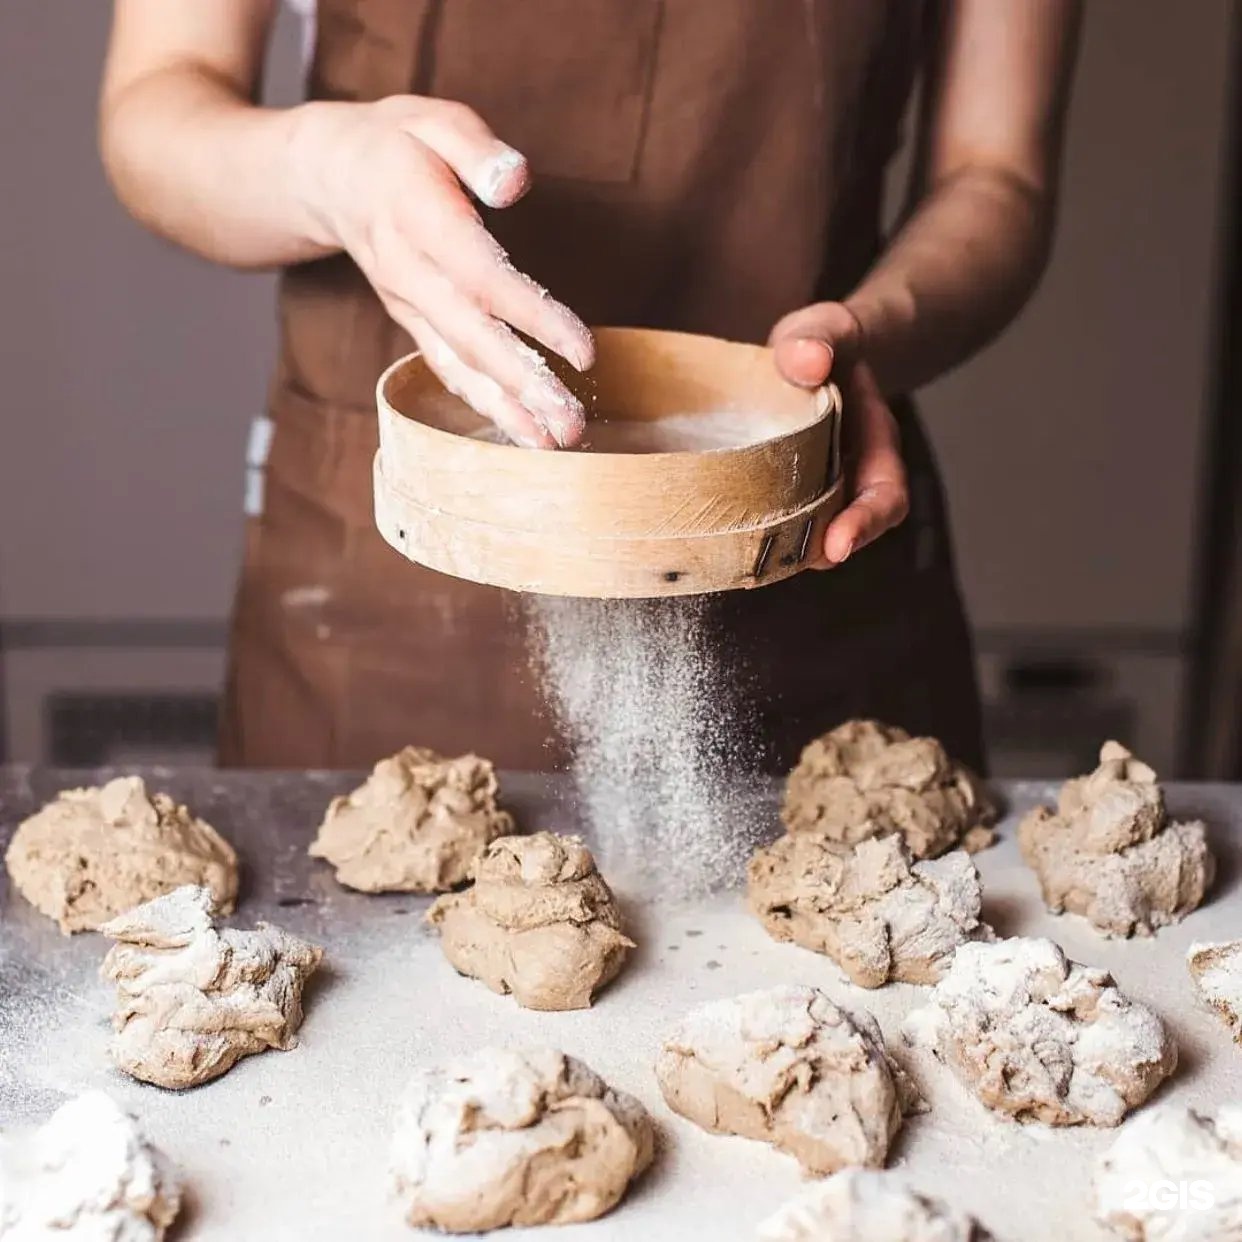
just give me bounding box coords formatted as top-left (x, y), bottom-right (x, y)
top-left (376, 328), bottom-right (841, 535)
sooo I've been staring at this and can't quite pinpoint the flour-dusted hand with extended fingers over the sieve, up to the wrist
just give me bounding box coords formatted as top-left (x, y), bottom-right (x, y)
top-left (291, 96), bottom-right (595, 448)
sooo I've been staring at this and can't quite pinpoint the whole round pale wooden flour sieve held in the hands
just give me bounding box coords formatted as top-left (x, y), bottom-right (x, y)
top-left (375, 328), bottom-right (843, 597)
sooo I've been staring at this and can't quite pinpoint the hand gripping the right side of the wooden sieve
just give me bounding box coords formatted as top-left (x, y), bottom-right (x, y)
top-left (768, 302), bottom-right (909, 569)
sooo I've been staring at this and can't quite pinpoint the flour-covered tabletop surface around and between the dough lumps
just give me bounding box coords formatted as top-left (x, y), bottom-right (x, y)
top-left (0, 769), bottom-right (1242, 1242)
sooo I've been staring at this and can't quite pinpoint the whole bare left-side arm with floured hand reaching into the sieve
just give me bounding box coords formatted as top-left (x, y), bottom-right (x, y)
top-left (99, 0), bottom-right (595, 447)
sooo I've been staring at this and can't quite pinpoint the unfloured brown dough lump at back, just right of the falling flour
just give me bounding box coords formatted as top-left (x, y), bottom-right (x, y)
top-left (781, 720), bottom-right (996, 858)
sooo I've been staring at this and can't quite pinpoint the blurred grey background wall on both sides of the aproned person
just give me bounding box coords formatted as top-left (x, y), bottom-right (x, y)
top-left (0, 0), bottom-right (1235, 769)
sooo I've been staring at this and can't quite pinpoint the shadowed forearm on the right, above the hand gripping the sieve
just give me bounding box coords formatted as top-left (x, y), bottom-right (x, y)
top-left (846, 168), bottom-right (1052, 394)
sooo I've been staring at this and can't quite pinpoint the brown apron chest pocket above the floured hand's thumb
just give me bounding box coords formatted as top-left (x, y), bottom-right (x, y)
top-left (428, 0), bottom-right (662, 183)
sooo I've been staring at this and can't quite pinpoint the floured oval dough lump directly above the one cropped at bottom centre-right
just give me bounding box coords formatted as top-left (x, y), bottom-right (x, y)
top-left (656, 986), bottom-right (920, 1176)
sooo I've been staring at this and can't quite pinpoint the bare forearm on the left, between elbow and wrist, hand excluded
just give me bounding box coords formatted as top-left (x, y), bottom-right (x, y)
top-left (101, 63), bottom-right (332, 267)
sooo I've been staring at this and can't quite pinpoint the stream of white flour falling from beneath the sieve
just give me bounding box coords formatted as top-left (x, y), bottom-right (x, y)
top-left (528, 596), bottom-right (761, 897)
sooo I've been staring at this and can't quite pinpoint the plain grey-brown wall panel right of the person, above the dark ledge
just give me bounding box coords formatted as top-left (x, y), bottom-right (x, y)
top-left (925, 0), bottom-right (1235, 633)
